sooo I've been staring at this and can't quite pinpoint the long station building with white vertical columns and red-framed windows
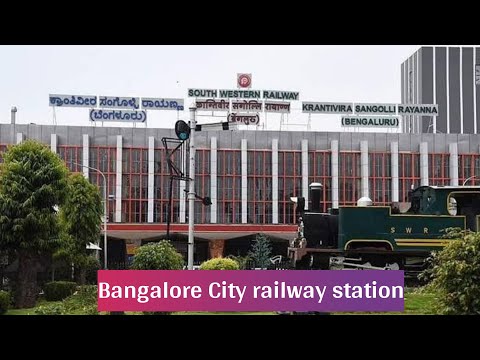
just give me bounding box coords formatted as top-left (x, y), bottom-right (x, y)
top-left (0, 123), bottom-right (480, 262)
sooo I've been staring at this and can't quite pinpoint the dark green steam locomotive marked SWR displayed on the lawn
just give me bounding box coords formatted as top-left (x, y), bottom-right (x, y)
top-left (288, 183), bottom-right (480, 273)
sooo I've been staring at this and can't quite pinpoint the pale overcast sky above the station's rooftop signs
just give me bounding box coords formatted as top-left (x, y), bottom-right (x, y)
top-left (0, 45), bottom-right (420, 131)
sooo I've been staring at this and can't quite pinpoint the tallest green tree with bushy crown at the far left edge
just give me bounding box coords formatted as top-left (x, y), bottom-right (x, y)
top-left (0, 140), bottom-right (68, 308)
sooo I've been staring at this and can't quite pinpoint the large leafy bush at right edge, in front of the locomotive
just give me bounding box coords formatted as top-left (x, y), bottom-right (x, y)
top-left (423, 228), bottom-right (480, 315)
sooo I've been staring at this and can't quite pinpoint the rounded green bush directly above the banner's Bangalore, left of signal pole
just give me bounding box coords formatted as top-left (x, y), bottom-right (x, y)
top-left (132, 240), bottom-right (184, 270)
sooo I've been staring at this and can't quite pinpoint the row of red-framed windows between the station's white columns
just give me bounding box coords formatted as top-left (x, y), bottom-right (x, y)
top-left (0, 145), bottom-right (480, 223)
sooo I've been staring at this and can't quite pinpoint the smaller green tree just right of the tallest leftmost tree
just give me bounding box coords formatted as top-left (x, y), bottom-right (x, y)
top-left (56, 174), bottom-right (103, 285)
